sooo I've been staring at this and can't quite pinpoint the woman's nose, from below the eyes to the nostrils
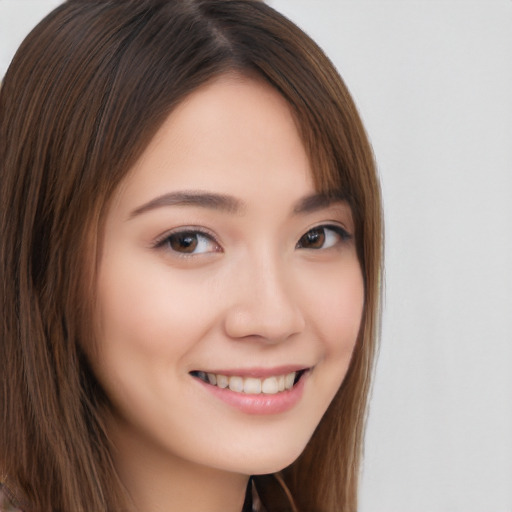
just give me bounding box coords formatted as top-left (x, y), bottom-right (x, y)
top-left (225, 253), bottom-right (305, 343)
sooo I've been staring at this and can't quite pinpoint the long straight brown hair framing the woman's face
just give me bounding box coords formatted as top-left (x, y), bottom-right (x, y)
top-left (0, 0), bottom-right (381, 512)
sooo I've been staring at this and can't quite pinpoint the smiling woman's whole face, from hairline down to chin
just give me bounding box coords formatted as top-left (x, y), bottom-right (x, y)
top-left (92, 76), bottom-right (364, 474)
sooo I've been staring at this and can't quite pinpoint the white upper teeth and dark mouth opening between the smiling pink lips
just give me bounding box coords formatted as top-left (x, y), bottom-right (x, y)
top-left (190, 370), bottom-right (307, 395)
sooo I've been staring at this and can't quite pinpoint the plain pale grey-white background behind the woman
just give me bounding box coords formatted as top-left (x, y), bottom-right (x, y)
top-left (0, 0), bottom-right (512, 512)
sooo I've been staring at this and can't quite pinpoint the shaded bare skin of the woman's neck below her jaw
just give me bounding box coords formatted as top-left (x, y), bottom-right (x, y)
top-left (113, 420), bottom-right (249, 512)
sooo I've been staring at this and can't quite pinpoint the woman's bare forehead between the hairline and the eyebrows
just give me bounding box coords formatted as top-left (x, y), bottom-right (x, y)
top-left (115, 75), bottom-right (314, 213)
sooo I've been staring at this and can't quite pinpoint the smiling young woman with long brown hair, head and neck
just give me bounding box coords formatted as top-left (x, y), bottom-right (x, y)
top-left (0, 0), bottom-right (381, 512)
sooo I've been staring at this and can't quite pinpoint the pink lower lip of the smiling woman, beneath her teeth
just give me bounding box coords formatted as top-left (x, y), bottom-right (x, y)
top-left (196, 372), bottom-right (309, 415)
